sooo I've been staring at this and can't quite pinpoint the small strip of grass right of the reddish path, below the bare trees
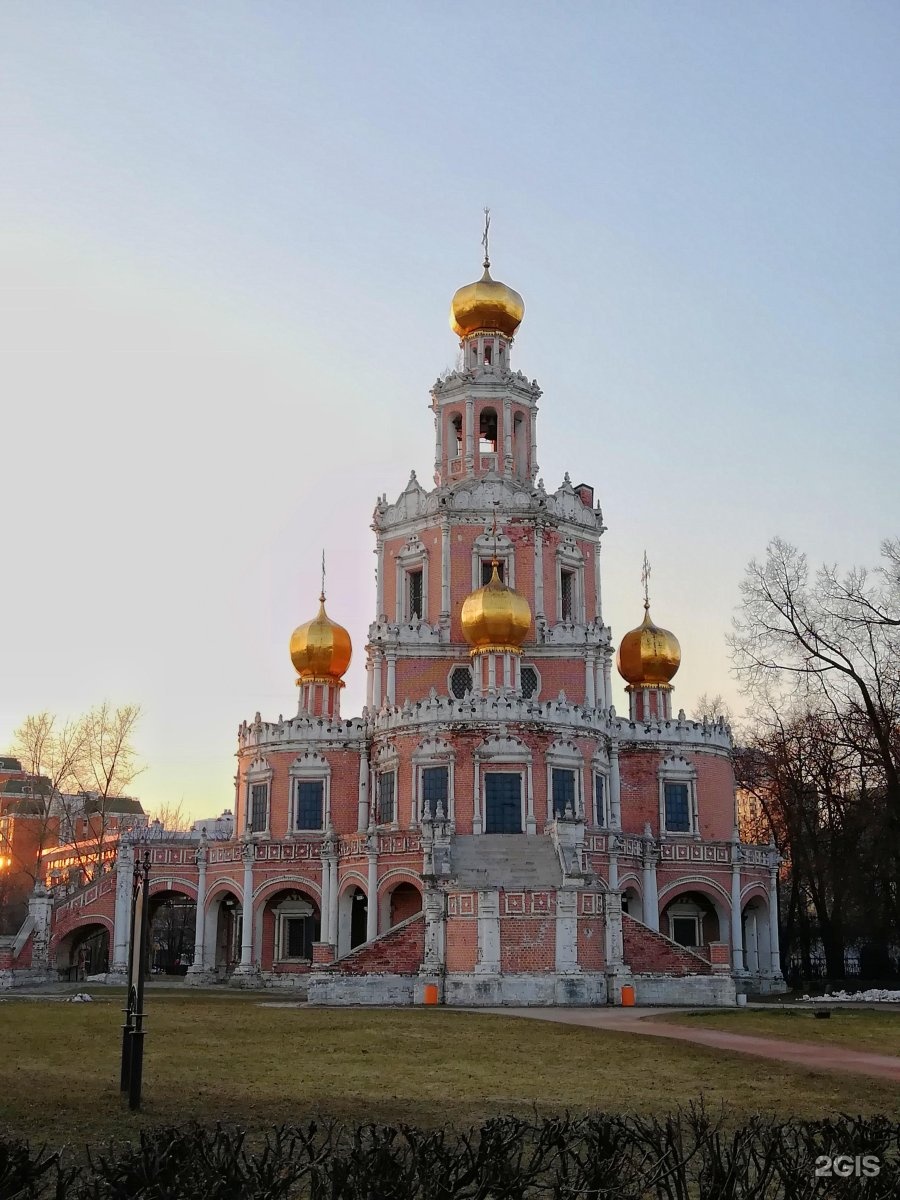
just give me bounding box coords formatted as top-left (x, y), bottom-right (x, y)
top-left (653, 1004), bottom-right (900, 1055)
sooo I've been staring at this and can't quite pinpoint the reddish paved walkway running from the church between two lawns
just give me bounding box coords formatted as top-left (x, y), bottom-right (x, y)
top-left (489, 1008), bottom-right (900, 1084)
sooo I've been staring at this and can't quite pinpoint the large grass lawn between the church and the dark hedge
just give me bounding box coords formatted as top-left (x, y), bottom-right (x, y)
top-left (0, 990), bottom-right (898, 1146)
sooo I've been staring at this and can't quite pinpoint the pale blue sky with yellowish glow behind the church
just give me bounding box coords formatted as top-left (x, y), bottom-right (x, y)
top-left (0, 0), bottom-right (900, 817)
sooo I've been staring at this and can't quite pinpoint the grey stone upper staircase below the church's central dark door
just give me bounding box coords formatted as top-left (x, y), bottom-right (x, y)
top-left (450, 833), bottom-right (563, 892)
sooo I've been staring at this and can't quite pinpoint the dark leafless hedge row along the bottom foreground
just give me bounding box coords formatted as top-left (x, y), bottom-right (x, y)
top-left (0, 1108), bottom-right (900, 1200)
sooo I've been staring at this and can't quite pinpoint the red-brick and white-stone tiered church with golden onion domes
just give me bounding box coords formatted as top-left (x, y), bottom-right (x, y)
top-left (0, 246), bottom-right (784, 1006)
